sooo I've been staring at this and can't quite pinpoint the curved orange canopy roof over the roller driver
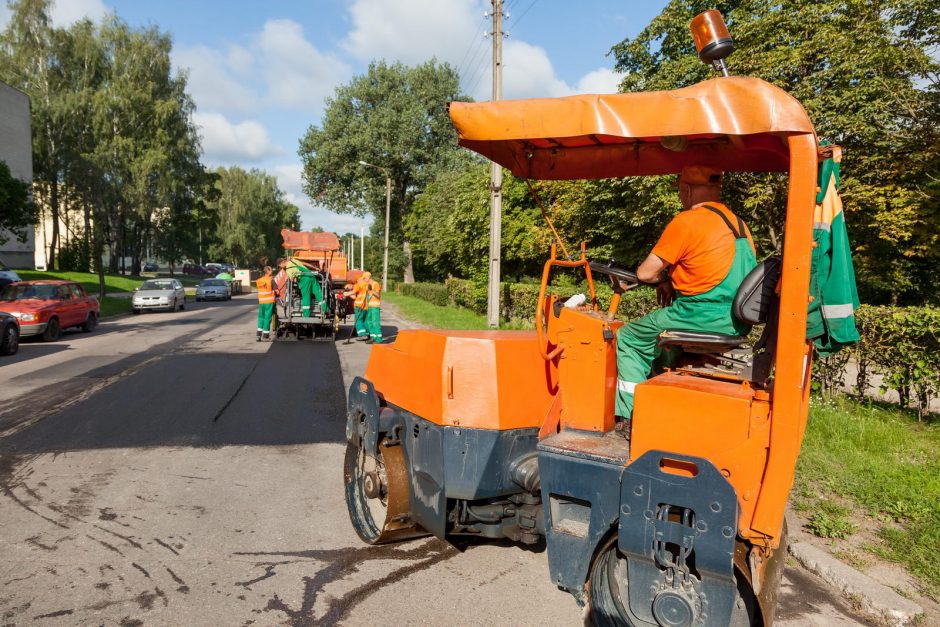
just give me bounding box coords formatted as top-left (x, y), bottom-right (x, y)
top-left (449, 77), bottom-right (815, 179)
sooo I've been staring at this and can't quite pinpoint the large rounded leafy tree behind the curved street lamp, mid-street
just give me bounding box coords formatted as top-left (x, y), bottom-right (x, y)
top-left (299, 60), bottom-right (460, 282)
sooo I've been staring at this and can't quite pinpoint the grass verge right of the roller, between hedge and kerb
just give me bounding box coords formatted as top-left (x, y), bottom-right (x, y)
top-left (794, 397), bottom-right (940, 599)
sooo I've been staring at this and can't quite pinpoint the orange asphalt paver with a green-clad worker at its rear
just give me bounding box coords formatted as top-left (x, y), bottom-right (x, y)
top-left (275, 229), bottom-right (352, 340)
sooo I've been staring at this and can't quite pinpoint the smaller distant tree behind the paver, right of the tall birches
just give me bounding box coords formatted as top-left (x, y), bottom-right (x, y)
top-left (208, 167), bottom-right (300, 265)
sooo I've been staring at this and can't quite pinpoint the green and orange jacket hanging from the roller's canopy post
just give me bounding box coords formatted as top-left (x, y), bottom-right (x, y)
top-left (806, 146), bottom-right (859, 357)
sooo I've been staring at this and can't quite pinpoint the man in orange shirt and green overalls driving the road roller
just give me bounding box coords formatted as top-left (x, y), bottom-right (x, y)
top-left (615, 166), bottom-right (757, 418)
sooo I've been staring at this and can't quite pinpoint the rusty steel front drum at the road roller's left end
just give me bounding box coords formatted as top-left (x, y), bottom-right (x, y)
top-left (344, 442), bottom-right (426, 544)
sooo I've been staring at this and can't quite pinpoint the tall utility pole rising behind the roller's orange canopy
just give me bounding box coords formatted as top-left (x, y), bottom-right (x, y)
top-left (486, 0), bottom-right (503, 327)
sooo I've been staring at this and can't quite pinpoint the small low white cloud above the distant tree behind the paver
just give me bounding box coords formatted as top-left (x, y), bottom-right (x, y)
top-left (193, 112), bottom-right (283, 164)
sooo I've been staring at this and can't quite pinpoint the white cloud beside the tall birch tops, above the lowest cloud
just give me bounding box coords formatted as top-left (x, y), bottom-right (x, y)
top-left (173, 46), bottom-right (260, 113)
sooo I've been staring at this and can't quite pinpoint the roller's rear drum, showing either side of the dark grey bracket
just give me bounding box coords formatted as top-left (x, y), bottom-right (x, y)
top-left (586, 534), bottom-right (760, 627)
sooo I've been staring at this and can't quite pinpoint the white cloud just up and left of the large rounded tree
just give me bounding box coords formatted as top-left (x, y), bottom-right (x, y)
top-left (256, 20), bottom-right (351, 112)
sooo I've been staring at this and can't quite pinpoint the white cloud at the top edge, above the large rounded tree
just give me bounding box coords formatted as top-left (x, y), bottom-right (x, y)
top-left (342, 0), bottom-right (482, 65)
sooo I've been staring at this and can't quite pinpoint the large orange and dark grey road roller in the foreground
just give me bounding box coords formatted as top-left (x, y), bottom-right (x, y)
top-left (344, 12), bottom-right (831, 626)
